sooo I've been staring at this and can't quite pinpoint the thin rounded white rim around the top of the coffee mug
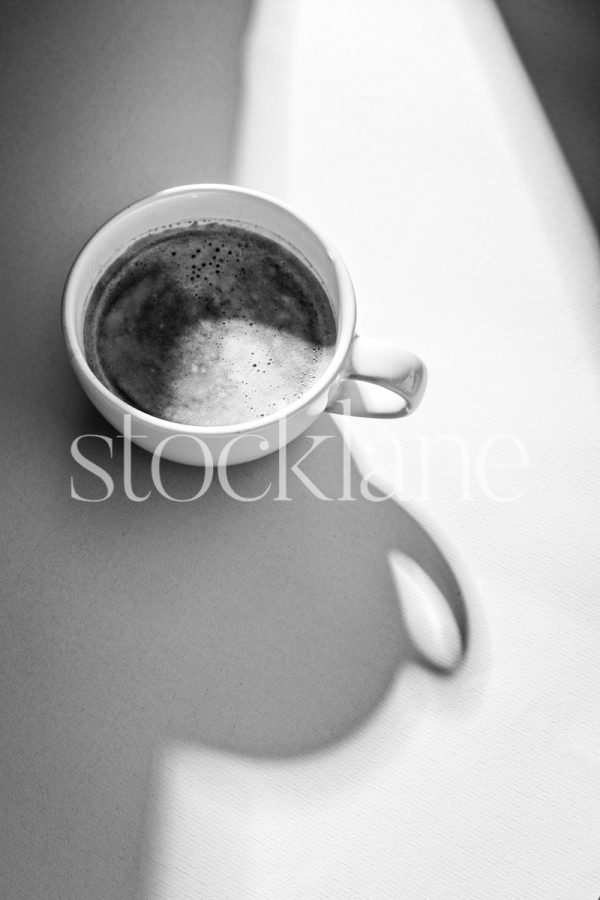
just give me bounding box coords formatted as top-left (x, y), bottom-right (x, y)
top-left (61, 183), bottom-right (356, 436)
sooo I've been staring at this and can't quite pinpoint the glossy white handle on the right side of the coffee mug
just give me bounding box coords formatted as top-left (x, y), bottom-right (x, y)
top-left (327, 335), bottom-right (427, 418)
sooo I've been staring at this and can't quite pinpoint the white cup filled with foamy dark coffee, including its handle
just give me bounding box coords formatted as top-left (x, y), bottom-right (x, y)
top-left (62, 184), bottom-right (426, 466)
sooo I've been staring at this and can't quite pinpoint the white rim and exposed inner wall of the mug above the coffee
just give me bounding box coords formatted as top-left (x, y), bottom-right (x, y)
top-left (63, 185), bottom-right (355, 432)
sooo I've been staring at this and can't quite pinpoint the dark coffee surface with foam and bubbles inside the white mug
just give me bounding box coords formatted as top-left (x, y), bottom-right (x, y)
top-left (85, 222), bottom-right (336, 425)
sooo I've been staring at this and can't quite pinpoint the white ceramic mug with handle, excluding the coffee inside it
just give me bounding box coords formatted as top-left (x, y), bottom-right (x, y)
top-left (62, 184), bottom-right (426, 465)
